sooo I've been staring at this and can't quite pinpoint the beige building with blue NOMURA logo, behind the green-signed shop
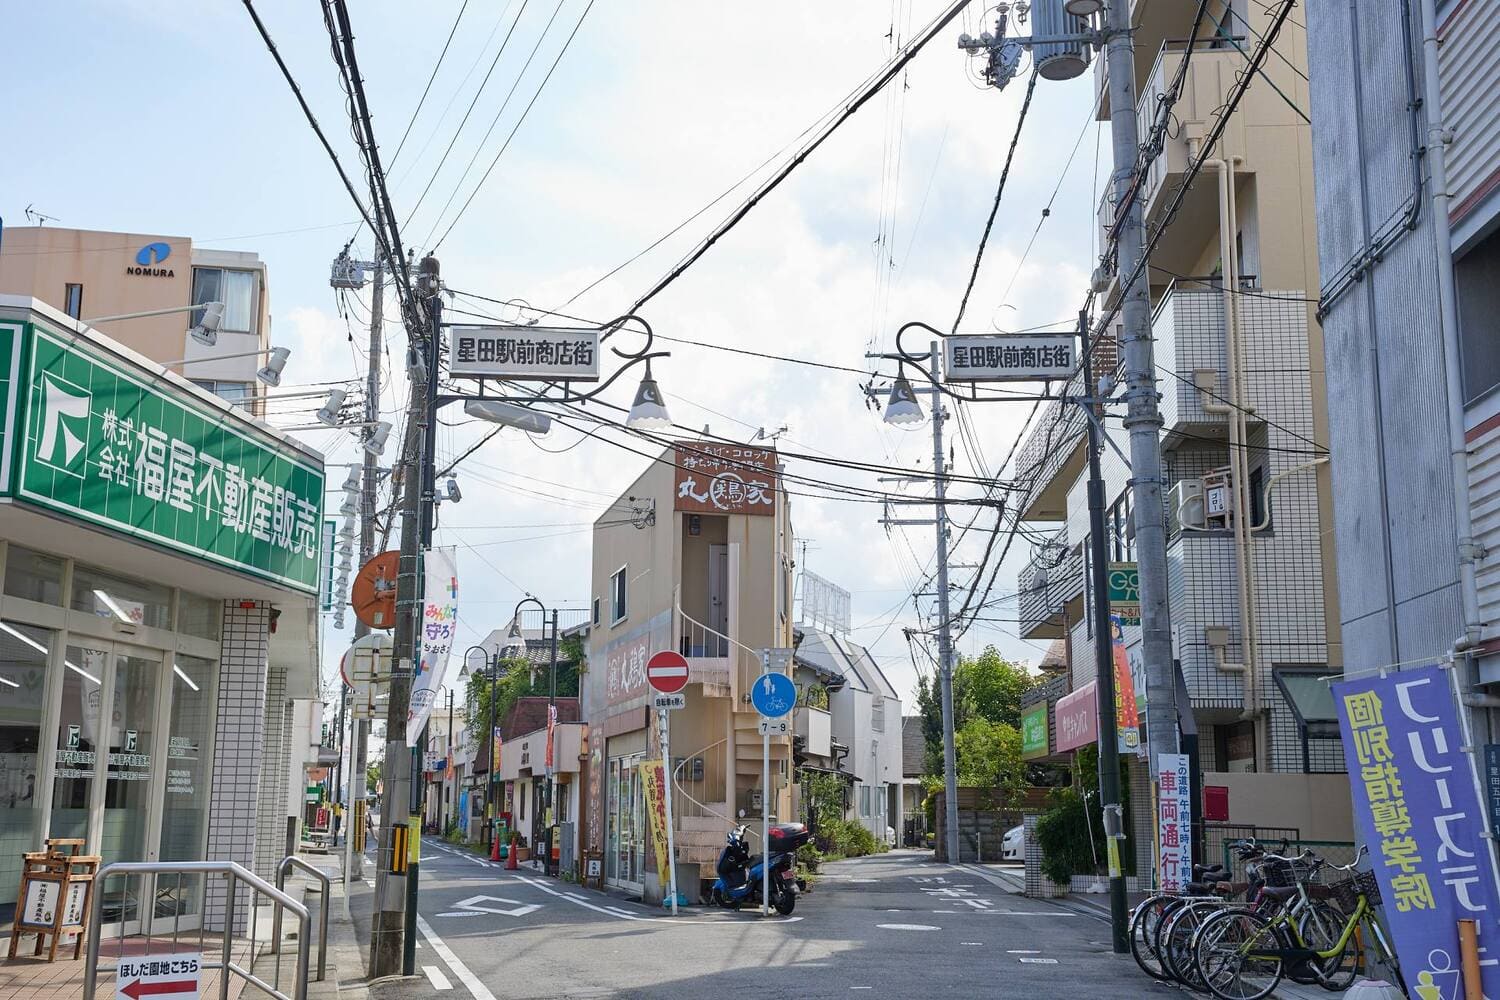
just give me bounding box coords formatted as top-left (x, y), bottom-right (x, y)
top-left (0, 226), bottom-right (272, 415)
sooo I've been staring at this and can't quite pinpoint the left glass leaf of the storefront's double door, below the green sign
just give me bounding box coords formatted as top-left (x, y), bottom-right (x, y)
top-left (50, 646), bottom-right (114, 861)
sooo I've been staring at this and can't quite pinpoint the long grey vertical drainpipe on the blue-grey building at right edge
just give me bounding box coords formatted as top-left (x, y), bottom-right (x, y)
top-left (1422, 0), bottom-right (1485, 654)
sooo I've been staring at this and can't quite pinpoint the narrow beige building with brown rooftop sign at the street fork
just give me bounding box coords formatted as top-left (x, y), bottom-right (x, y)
top-left (582, 442), bottom-right (795, 898)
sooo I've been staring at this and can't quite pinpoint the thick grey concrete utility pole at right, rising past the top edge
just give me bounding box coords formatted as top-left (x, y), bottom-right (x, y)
top-left (1106, 0), bottom-right (1178, 774)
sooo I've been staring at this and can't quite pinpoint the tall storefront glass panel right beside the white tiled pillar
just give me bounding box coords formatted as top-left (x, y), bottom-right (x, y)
top-left (156, 655), bottom-right (219, 916)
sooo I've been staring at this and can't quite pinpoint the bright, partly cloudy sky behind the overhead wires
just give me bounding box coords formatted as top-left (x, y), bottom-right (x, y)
top-left (0, 0), bottom-right (1109, 712)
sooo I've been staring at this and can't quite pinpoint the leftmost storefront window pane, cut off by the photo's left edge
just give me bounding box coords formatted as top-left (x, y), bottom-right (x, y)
top-left (0, 620), bottom-right (51, 924)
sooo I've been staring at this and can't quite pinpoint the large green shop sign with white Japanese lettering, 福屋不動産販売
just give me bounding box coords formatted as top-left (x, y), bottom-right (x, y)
top-left (0, 324), bottom-right (323, 594)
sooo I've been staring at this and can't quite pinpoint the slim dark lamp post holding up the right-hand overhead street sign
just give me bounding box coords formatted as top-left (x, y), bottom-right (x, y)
top-left (1079, 312), bottom-right (1130, 955)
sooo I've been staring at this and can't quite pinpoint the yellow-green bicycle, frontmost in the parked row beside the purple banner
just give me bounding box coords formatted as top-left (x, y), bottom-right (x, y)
top-left (1193, 849), bottom-right (1406, 1000)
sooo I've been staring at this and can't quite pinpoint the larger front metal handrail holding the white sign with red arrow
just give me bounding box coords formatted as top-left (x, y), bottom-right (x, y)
top-left (84, 861), bottom-right (311, 1000)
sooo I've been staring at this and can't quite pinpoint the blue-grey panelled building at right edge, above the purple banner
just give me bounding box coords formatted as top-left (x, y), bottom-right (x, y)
top-left (1307, 0), bottom-right (1500, 742)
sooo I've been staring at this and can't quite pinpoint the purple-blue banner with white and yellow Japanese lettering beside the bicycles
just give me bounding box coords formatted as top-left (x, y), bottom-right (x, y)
top-left (1334, 667), bottom-right (1500, 1000)
